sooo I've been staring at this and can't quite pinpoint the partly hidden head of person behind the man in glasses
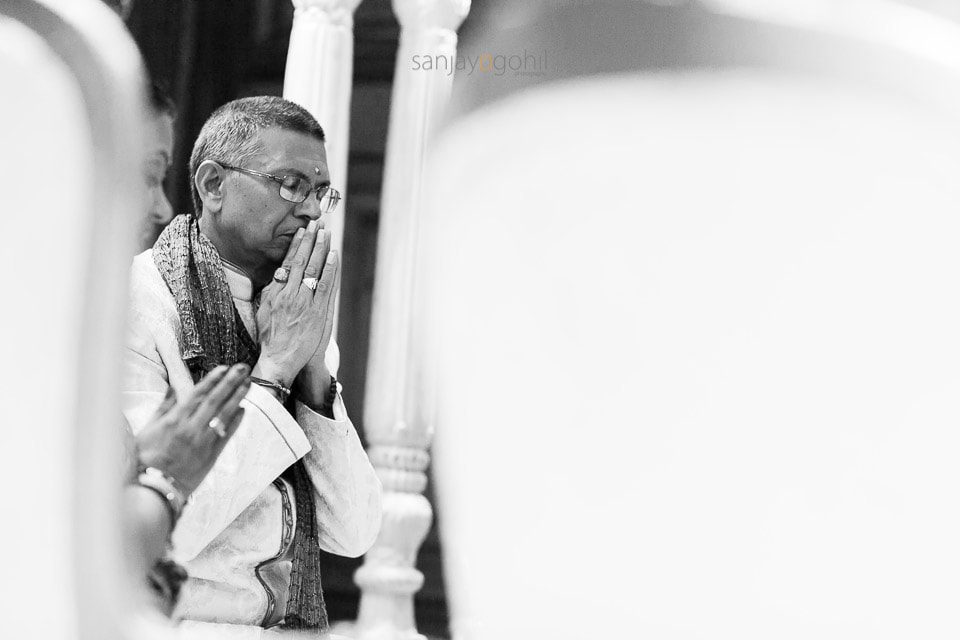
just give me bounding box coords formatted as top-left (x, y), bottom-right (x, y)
top-left (140, 84), bottom-right (174, 249)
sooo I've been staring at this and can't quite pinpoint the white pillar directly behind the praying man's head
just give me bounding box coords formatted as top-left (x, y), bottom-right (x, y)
top-left (283, 0), bottom-right (361, 264)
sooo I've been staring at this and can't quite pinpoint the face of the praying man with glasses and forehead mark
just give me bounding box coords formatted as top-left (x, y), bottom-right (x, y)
top-left (211, 128), bottom-right (330, 272)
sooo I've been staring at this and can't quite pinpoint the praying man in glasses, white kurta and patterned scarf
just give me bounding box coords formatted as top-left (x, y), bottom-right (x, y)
top-left (123, 97), bottom-right (381, 639)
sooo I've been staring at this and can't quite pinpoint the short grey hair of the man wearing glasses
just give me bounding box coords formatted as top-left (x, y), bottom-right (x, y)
top-left (190, 96), bottom-right (326, 218)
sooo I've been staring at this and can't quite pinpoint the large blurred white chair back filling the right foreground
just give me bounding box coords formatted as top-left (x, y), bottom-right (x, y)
top-left (423, 0), bottom-right (960, 640)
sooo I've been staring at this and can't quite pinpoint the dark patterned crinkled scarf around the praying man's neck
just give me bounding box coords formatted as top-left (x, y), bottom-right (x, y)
top-left (153, 215), bottom-right (328, 631)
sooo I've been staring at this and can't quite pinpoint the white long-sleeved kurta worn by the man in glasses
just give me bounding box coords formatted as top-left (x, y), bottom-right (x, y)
top-left (123, 250), bottom-right (381, 632)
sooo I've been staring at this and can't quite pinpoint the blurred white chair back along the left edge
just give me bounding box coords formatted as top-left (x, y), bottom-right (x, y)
top-left (0, 0), bottom-right (144, 640)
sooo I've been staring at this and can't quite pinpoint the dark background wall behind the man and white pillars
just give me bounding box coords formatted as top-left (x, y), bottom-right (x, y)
top-left (127, 0), bottom-right (484, 637)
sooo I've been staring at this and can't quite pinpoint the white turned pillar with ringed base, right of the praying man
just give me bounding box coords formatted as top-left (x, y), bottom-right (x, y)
top-left (355, 0), bottom-right (470, 640)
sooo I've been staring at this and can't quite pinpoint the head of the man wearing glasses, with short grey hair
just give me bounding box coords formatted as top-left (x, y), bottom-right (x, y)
top-left (190, 96), bottom-right (339, 284)
